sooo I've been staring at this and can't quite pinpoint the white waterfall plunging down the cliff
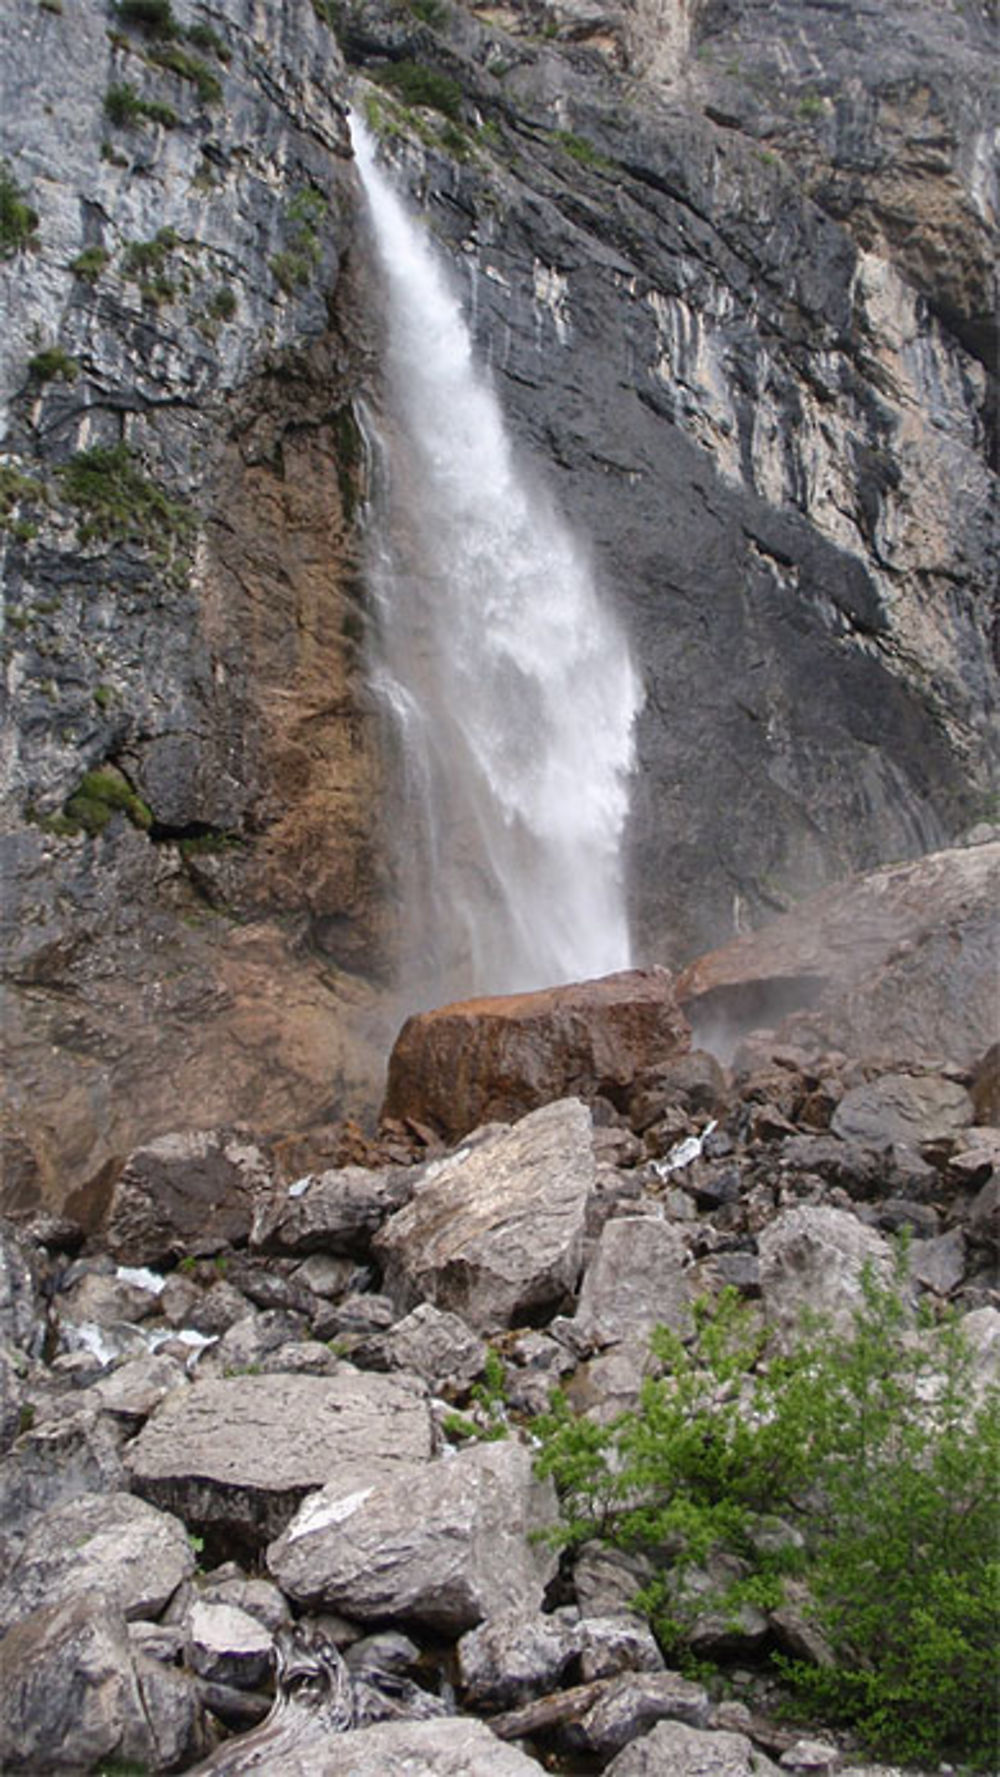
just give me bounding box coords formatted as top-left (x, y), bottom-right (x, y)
top-left (352, 117), bottom-right (641, 1008)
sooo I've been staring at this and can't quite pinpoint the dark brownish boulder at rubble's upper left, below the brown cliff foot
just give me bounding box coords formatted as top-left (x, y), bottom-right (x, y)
top-left (105, 1128), bottom-right (274, 1265)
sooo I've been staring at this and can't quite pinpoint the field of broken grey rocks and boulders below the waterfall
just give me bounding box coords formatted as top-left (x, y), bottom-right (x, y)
top-left (0, 1032), bottom-right (1000, 1777)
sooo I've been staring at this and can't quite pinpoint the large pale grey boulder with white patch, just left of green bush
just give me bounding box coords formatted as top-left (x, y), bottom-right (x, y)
top-left (266, 1441), bottom-right (556, 1635)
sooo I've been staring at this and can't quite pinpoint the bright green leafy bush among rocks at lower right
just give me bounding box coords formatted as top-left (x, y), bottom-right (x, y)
top-left (535, 1274), bottom-right (1000, 1768)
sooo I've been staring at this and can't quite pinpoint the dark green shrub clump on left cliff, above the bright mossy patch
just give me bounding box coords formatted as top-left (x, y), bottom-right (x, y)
top-left (59, 444), bottom-right (194, 558)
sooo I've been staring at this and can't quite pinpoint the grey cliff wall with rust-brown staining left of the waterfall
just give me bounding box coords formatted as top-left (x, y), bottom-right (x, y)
top-left (0, 0), bottom-right (392, 1203)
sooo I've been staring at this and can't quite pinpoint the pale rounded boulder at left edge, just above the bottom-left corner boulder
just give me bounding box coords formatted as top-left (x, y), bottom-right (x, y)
top-left (0, 1493), bottom-right (195, 1631)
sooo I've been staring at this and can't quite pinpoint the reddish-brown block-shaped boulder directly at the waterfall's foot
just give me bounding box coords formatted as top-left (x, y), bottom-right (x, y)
top-left (382, 968), bottom-right (691, 1141)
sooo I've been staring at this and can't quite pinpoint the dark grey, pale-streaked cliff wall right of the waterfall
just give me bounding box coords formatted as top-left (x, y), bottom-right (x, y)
top-left (341, 4), bottom-right (996, 961)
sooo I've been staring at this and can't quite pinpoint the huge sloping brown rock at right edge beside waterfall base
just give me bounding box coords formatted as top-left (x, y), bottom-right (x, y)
top-left (677, 841), bottom-right (1000, 1066)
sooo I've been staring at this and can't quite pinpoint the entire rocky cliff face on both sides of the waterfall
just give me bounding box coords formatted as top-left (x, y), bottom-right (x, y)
top-left (0, 0), bottom-right (996, 1201)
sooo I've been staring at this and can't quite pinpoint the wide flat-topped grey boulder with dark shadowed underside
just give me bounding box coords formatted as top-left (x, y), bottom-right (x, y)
top-left (126, 1365), bottom-right (432, 1544)
